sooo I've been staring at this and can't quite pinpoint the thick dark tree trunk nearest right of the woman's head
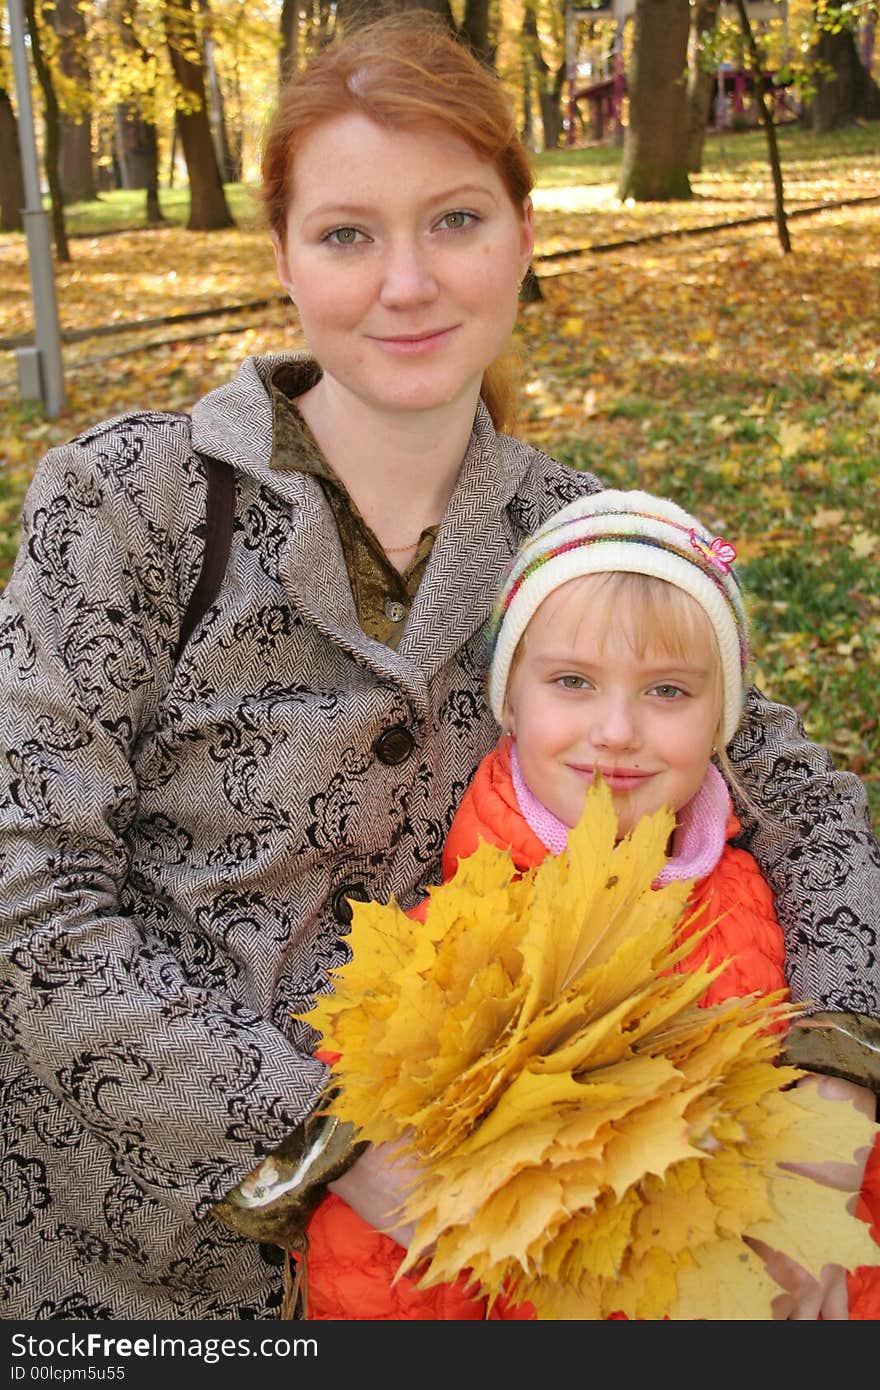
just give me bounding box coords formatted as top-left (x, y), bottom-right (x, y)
top-left (617, 0), bottom-right (691, 203)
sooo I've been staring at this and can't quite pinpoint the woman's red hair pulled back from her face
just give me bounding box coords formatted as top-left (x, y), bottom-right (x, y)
top-left (261, 11), bottom-right (534, 430)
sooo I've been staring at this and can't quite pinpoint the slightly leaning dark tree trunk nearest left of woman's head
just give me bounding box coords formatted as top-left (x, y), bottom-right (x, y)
top-left (164, 0), bottom-right (235, 232)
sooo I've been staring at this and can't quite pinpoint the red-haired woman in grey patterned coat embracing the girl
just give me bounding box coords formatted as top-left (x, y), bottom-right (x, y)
top-left (0, 19), bottom-right (880, 1319)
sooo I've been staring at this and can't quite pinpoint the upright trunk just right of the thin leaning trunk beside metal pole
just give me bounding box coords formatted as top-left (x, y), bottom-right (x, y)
top-left (49, 0), bottom-right (97, 203)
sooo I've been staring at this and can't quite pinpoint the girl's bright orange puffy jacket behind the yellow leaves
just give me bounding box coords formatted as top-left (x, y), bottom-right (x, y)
top-left (307, 739), bottom-right (880, 1321)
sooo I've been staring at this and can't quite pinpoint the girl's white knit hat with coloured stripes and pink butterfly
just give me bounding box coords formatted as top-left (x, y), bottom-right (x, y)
top-left (489, 488), bottom-right (748, 744)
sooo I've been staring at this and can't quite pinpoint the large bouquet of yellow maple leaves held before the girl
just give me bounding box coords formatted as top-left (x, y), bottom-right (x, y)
top-left (300, 785), bottom-right (877, 1319)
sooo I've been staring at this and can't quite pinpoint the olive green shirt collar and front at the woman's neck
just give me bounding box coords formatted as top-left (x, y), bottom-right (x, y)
top-left (268, 361), bottom-right (438, 648)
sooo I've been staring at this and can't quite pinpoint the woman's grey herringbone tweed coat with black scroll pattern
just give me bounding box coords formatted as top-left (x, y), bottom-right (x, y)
top-left (0, 357), bottom-right (880, 1319)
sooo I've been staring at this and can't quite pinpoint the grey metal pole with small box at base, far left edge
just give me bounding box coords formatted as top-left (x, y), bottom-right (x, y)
top-left (7, 0), bottom-right (64, 418)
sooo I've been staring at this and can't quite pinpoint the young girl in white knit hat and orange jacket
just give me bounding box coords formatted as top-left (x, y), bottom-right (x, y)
top-left (309, 491), bottom-right (880, 1318)
